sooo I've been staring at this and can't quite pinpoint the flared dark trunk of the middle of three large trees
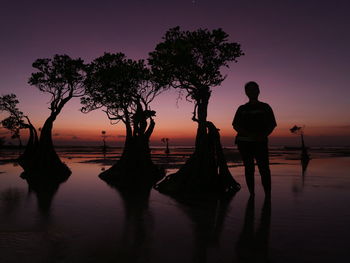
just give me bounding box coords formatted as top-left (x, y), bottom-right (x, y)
top-left (99, 120), bottom-right (163, 188)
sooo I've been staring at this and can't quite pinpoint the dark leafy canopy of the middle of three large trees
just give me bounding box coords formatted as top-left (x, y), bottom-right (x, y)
top-left (81, 53), bottom-right (161, 126)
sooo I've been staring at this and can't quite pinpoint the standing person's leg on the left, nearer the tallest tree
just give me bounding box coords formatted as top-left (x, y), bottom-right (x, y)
top-left (237, 142), bottom-right (255, 195)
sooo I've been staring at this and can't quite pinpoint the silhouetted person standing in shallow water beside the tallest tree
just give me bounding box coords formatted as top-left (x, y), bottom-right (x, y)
top-left (232, 81), bottom-right (276, 196)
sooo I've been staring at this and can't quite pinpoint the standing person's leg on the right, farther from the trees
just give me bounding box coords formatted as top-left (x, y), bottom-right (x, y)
top-left (255, 142), bottom-right (271, 196)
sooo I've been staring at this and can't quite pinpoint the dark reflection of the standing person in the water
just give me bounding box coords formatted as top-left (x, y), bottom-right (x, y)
top-left (236, 197), bottom-right (271, 263)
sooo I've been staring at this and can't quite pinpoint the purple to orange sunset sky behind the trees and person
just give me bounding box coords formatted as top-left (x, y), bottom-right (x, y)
top-left (0, 0), bottom-right (350, 146)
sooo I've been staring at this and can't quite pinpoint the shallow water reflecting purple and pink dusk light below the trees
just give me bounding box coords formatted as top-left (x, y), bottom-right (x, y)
top-left (0, 152), bottom-right (350, 263)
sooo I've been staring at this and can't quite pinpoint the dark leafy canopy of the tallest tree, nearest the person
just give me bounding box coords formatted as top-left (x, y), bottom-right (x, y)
top-left (149, 27), bottom-right (244, 100)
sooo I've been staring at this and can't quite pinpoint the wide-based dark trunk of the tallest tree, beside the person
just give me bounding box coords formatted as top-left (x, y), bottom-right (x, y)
top-left (155, 90), bottom-right (240, 196)
